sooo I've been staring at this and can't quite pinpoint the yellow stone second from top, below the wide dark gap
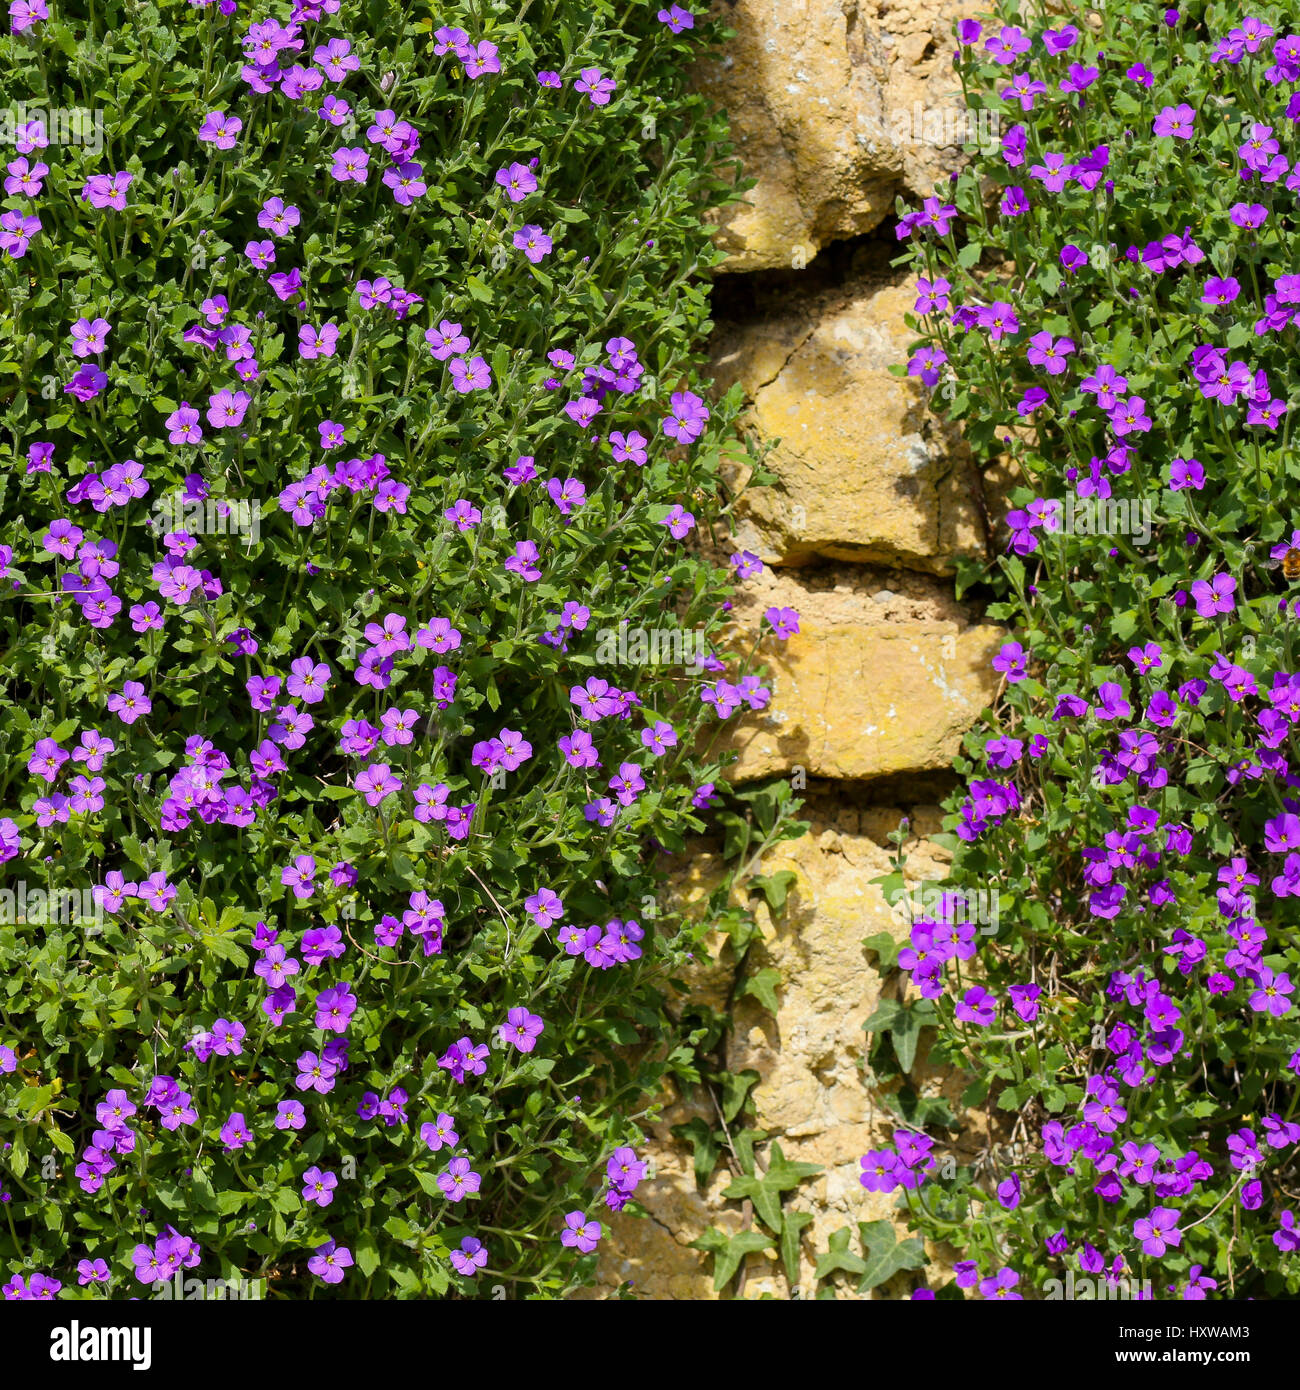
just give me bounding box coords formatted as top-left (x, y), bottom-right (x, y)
top-left (713, 262), bottom-right (984, 574)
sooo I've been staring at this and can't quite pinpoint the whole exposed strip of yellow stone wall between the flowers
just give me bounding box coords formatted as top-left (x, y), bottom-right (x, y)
top-left (583, 0), bottom-right (1000, 1298)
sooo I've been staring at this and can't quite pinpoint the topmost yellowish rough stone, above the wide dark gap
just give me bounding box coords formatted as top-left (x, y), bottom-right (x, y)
top-left (698, 0), bottom-right (979, 271)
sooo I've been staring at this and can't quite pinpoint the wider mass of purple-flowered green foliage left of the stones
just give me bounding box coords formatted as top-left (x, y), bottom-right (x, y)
top-left (0, 0), bottom-right (788, 1298)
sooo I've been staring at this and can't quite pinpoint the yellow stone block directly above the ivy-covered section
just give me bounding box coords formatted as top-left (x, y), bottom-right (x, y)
top-left (724, 567), bottom-right (1005, 781)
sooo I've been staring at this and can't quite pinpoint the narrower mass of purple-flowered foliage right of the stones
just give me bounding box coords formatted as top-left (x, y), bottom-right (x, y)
top-left (884, 0), bottom-right (1300, 1298)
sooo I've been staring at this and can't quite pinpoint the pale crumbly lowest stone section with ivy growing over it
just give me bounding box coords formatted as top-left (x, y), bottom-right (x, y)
top-left (598, 795), bottom-right (978, 1298)
